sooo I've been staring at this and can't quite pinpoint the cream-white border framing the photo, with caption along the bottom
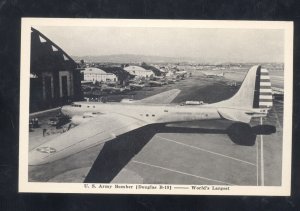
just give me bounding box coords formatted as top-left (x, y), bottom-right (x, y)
top-left (19, 18), bottom-right (293, 196)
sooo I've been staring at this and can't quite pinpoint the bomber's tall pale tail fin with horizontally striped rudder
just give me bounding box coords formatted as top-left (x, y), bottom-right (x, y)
top-left (214, 65), bottom-right (273, 122)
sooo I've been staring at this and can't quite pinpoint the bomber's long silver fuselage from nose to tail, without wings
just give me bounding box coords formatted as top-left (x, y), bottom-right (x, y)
top-left (62, 102), bottom-right (221, 124)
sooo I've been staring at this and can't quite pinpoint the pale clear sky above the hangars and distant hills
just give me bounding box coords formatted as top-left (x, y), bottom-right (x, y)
top-left (33, 26), bottom-right (284, 62)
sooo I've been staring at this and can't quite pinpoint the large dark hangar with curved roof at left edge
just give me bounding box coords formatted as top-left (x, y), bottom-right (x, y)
top-left (30, 28), bottom-right (82, 112)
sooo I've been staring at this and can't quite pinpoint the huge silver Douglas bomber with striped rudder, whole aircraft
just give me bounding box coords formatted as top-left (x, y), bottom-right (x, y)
top-left (29, 66), bottom-right (272, 165)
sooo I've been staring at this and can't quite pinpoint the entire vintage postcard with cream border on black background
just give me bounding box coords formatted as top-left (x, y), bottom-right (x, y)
top-left (19, 18), bottom-right (293, 196)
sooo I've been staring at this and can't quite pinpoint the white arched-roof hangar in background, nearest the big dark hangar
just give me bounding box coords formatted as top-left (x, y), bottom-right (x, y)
top-left (82, 67), bottom-right (118, 82)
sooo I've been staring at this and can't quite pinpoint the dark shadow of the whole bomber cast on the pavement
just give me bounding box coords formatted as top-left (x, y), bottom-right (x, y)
top-left (84, 122), bottom-right (276, 183)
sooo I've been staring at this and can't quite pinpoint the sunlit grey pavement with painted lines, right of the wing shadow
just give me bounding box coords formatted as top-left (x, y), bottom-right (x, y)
top-left (109, 99), bottom-right (282, 186)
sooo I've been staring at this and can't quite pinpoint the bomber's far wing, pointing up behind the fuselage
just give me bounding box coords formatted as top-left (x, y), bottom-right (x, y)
top-left (135, 89), bottom-right (181, 104)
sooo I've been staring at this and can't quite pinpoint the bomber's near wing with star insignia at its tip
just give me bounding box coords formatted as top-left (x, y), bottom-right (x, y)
top-left (29, 113), bottom-right (147, 165)
